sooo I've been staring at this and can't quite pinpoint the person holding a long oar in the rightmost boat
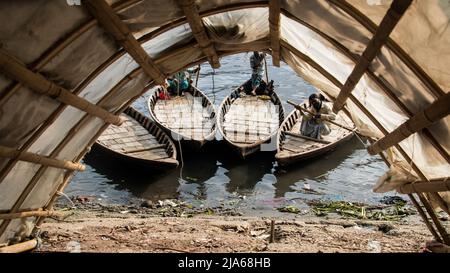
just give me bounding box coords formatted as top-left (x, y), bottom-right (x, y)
top-left (300, 94), bottom-right (336, 139)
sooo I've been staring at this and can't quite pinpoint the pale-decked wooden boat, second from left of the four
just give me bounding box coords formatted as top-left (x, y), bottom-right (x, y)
top-left (147, 86), bottom-right (216, 151)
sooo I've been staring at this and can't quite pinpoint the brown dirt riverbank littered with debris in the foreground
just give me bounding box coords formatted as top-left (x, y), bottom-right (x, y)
top-left (36, 202), bottom-right (433, 253)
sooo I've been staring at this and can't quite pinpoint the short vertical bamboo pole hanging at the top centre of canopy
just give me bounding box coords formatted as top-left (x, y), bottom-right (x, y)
top-left (269, 0), bottom-right (281, 67)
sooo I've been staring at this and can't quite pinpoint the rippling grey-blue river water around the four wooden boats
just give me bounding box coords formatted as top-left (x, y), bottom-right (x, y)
top-left (65, 53), bottom-right (393, 212)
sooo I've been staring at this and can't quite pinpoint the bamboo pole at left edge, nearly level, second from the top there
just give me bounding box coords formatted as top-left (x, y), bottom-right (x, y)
top-left (0, 146), bottom-right (86, 171)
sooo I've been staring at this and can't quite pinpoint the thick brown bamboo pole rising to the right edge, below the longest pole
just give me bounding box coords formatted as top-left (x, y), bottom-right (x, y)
top-left (367, 93), bottom-right (450, 155)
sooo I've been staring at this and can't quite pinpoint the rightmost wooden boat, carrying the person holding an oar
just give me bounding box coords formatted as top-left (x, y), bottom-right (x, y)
top-left (275, 101), bottom-right (355, 165)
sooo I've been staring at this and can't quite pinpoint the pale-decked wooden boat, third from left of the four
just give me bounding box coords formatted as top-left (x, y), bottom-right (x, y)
top-left (217, 83), bottom-right (284, 158)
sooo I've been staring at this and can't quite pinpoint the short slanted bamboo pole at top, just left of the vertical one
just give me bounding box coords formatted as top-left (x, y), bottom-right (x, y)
top-left (178, 0), bottom-right (220, 69)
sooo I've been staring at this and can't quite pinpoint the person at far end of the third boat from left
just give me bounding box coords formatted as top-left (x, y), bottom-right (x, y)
top-left (241, 51), bottom-right (267, 96)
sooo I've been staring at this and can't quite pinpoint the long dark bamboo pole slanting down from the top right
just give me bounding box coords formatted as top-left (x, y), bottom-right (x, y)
top-left (333, 0), bottom-right (412, 113)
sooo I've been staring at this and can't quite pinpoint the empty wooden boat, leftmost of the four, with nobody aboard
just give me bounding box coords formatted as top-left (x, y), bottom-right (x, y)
top-left (96, 107), bottom-right (178, 170)
